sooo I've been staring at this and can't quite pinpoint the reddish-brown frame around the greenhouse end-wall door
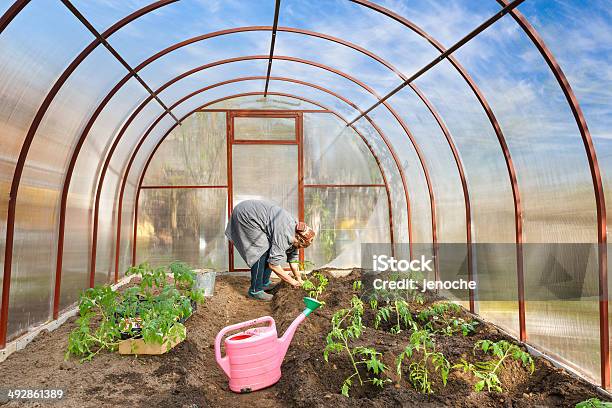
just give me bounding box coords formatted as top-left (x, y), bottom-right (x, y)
top-left (226, 110), bottom-right (304, 272)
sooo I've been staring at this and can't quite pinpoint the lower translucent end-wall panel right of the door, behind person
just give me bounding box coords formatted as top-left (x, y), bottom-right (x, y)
top-left (304, 187), bottom-right (391, 268)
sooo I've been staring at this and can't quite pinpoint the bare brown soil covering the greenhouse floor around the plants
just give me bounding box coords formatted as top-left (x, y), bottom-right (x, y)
top-left (0, 271), bottom-right (604, 408)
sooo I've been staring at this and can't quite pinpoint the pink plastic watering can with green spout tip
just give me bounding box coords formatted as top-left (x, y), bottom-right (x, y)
top-left (215, 297), bottom-right (321, 393)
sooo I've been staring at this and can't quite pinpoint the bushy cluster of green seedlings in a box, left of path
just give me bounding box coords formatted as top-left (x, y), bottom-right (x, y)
top-left (65, 263), bottom-right (204, 361)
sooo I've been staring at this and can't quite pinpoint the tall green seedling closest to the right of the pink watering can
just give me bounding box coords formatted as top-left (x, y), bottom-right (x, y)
top-left (323, 296), bottom-right (391, 397)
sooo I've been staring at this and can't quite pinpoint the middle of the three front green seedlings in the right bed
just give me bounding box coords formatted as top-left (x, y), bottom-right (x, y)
top-left (395, 330), bottom-right (451, 394)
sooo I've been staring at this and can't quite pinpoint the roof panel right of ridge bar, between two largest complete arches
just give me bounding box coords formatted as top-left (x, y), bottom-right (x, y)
top-left (273, 30), bottom-right (402, 95)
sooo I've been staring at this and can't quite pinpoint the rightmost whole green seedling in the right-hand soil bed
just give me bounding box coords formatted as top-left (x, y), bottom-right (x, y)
top-left (453, 340), bottom-right (535, 392)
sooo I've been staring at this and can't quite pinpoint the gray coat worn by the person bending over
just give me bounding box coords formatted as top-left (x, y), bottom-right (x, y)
top-left (225, 200), bottom-right (298, 267)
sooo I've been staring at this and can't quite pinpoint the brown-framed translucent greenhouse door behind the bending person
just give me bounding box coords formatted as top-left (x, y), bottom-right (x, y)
top-left (227, 111), bottom-right (304, 271)
